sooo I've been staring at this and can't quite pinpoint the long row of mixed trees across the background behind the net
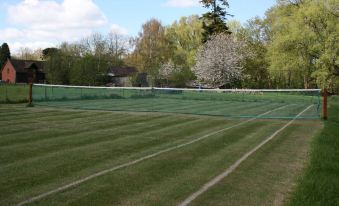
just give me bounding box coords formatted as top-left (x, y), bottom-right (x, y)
top-left (1, 0), bottom-right (339, 88)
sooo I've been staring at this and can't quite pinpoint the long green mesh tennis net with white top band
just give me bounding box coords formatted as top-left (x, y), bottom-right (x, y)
top-left (33, 84), bottom-right (321, 119)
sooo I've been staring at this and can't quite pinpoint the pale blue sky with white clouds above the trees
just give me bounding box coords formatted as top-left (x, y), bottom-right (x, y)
top-left (0, 0), bottom-right (275, 53)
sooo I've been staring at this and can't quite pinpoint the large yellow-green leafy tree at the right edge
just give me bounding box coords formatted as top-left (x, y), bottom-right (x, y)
top-left (267, 0), bottom-right (339, 88)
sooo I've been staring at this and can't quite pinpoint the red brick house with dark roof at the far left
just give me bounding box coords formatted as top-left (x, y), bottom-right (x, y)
top-left (1, 59), bottom-right (45, 83)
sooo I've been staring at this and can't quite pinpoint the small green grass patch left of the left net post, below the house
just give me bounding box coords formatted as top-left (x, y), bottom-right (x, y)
top-left (0, 84), bottom-right (29, 104)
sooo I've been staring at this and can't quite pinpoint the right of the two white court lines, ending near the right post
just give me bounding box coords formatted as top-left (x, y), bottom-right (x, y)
top-left (178, 105), bottom-right (313, 206)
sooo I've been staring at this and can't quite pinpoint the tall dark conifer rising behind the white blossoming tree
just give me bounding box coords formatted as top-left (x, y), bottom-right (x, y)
top-left (200, 0), bottom-right (230, 42)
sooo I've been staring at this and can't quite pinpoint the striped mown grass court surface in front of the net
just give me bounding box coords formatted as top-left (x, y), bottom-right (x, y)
top-left (0, 104), bottom-right (321, 205)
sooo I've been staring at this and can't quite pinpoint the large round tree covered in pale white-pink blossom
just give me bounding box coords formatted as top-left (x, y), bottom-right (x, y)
top-left (193, 33), bottom-right (244, 88)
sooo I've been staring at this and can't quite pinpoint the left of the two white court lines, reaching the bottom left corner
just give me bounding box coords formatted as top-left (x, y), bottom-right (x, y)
top-left (17, 105), bottom-right (289, 206)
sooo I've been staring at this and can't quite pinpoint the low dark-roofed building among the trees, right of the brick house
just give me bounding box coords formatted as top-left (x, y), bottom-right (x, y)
top-left (107, 67), bottom-right (138, 87)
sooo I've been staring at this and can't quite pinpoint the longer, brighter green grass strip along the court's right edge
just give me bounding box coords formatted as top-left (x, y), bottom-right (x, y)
top-left (289, 97), bottom-right (339, 206)
